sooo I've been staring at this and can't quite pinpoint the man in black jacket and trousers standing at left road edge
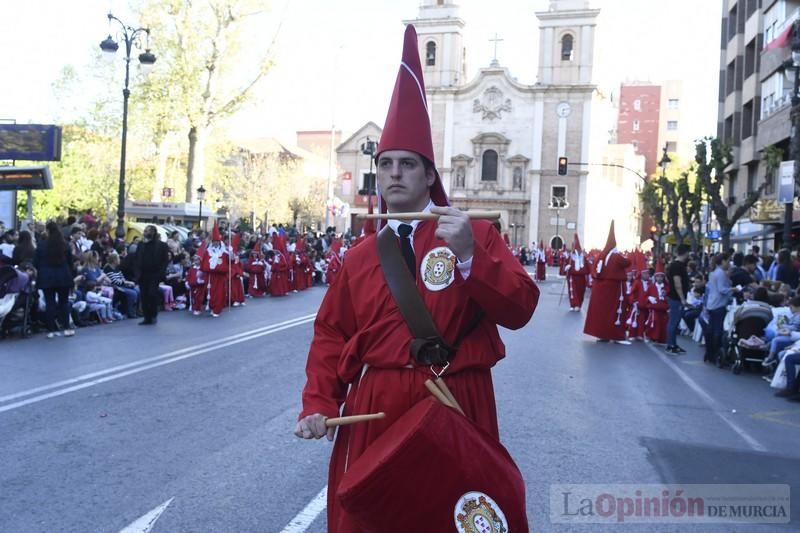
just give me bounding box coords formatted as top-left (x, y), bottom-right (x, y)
top-left (135, 225), bottom-right (169, 326)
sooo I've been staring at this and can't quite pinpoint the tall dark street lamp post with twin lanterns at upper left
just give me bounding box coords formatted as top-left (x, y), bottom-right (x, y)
top-left (100, 13), bottom-right (156, 239)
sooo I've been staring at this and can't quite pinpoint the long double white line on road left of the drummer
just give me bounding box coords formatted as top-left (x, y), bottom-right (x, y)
top-left (0, 314), bottom-right (316, 413)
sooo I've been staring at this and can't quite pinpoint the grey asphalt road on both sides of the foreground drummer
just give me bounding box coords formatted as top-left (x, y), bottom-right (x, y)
top-left (0, 270), bottom-right (800, 533)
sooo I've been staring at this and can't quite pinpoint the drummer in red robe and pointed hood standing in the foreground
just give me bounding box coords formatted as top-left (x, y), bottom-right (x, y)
top-left (295, 22), bottom-right (539, 533)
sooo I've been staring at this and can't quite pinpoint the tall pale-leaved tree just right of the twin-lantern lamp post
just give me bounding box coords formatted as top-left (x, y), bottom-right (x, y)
top-left (136, 0), bottom-right (277, 201)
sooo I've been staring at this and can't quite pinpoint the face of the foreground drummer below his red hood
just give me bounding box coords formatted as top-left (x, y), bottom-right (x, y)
top-left (378, 150), bottom-right (436, 212)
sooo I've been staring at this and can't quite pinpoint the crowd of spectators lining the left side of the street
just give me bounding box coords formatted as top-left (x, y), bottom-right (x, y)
top-left (0, 211), bottom-right (349, 338)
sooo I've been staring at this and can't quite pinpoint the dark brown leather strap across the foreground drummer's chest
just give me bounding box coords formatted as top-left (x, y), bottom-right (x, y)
top-left (376, 225), bottom-right (439, 339)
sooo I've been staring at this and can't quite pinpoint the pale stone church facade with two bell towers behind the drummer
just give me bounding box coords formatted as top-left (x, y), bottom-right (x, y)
top-left (404, 0), bottom-right (607, 247)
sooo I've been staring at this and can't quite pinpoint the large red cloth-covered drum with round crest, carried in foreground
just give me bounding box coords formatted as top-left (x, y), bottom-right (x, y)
top-left (336, 398), bottom-right (528, 533)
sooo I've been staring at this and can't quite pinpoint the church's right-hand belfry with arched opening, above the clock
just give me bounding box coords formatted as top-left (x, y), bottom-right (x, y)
top-left (536, 0), bottom-right (600, 85)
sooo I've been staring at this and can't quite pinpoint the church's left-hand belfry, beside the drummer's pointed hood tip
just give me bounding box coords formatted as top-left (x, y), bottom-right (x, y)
top-left (403, 0), bottom-right (466, 89)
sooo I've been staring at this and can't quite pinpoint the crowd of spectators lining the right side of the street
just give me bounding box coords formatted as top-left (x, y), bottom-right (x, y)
top-left (648, 246), bottom-right (800, 401)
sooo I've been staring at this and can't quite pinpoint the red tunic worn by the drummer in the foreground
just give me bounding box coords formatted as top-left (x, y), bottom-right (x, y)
top-left (300, 221), bottom-right (539, 533)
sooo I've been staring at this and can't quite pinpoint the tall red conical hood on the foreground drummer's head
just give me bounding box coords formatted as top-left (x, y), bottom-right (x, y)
top-left (375, 24), bottom-right (450, 227)
